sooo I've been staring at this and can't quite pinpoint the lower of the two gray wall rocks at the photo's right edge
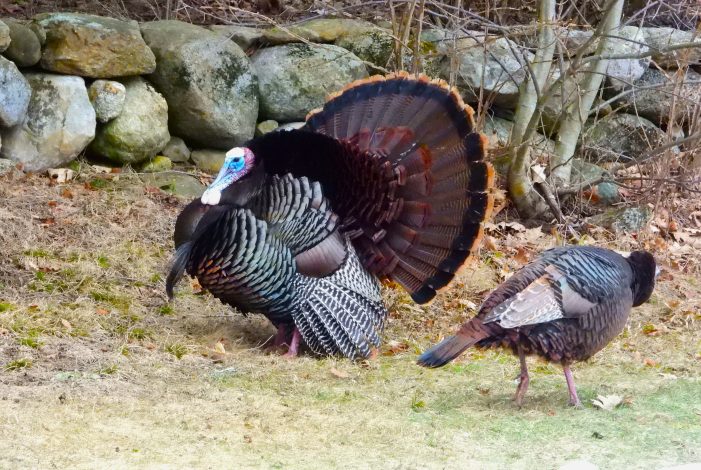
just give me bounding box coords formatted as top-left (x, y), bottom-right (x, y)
top-left (606, 68), bottom-right (701, 125)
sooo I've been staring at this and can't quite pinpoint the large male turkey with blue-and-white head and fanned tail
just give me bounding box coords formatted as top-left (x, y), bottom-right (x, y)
top-left (167, 73), bottom-right (493, 358)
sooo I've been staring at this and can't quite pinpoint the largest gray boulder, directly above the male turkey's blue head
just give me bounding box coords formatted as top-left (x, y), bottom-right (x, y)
top-left (141, 21), bottom-right (258, 149)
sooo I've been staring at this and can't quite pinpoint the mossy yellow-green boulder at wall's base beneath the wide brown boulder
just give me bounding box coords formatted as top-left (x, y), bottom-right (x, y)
top-left (90, 77), bottom-right (170, 165)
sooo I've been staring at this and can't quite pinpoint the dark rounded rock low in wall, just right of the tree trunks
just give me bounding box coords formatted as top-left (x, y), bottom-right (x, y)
top-left (579, 114), bottom-right (678, 163)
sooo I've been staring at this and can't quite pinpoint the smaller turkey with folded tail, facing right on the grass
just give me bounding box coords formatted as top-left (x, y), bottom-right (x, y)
top-left (418, 247), bottom-right (657, 406)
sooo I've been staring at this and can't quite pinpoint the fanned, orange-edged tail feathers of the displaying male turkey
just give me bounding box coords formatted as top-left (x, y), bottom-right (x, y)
top-left (305, 73), bottom-right (494, 303)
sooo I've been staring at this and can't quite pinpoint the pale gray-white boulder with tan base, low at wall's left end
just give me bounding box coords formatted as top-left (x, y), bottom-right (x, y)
top-left (0, 73), bottom-right (96, 171)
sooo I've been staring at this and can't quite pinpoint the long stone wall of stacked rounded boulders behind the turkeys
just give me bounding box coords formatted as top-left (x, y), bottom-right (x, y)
top-left (0, 13), bottom-right (701, 206)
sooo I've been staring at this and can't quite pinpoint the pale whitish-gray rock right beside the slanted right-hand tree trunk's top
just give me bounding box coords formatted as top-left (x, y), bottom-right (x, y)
top-left (604, 26), bottom-right (650, 90)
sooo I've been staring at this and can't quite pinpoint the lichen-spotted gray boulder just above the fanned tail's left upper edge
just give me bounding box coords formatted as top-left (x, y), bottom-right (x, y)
top-left (253, 44), bottom-right (368, 121)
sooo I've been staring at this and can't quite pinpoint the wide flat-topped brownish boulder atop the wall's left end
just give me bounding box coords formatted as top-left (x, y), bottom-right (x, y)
top-left (35, 13), bottom-right (156, 78)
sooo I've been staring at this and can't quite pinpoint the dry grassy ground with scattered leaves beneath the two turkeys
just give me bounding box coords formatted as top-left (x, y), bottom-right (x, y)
top-left (0, 166), bottom-right (701, 469)
